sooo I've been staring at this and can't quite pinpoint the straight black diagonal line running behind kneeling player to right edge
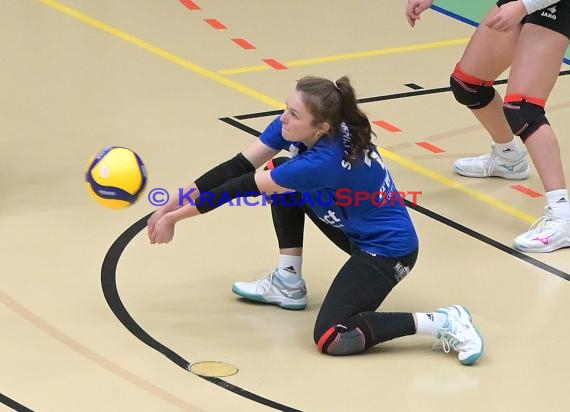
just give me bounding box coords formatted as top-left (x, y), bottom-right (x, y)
top-left (220, 117), bottom-right (570, 281)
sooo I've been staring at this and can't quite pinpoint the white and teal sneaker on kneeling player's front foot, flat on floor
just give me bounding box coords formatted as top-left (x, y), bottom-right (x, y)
top-left (232, 269), bottom-right (307, 310)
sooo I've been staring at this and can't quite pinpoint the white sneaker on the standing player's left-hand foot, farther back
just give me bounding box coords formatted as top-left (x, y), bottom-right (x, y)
top-left (453, 145), bottom-right (530, 180)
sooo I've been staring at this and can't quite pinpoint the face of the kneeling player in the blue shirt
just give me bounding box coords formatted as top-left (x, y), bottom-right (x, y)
top-left (281, 90), bottom-right (323, 146)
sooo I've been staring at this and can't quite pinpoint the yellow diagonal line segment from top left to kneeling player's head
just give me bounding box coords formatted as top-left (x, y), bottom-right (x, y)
top-left (36, 0), bottom-right (285, 109)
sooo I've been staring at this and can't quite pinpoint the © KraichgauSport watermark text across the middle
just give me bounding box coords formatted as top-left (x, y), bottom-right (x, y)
top-left (147, 187), bottom-right (423, 207)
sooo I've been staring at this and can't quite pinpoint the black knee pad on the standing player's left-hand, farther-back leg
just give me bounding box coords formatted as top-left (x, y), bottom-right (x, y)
top-left (449, 65), bottom-right (495, 109)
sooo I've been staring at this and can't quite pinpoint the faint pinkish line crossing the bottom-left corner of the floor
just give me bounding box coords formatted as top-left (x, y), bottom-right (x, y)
top-left (0, 290), bottom-right (203, 412)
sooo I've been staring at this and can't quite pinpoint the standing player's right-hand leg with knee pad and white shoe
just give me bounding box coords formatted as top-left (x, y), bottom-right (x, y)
top-left (504, 24), bottom-right (570, 252)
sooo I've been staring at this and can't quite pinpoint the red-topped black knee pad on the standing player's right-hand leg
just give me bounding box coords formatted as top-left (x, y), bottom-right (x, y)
top-left (503, 95), bottom-right (550, 142)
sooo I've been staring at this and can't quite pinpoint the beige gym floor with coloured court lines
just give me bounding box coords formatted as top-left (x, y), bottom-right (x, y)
top-left (0, 0), bottom-right (570, 412)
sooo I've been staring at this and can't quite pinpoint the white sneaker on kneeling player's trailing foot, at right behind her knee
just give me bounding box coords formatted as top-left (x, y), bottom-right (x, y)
top-left (434, 305), bottom-right (483, 365)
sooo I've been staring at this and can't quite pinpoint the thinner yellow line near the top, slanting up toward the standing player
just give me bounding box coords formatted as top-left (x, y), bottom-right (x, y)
top-left (218, 37), bottom-right (469, 75)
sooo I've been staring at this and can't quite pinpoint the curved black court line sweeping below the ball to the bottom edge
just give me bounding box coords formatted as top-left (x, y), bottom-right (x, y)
top-left (100, 213), bottom-right (299, 412)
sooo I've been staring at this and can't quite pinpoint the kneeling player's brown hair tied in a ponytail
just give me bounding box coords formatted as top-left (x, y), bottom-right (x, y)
top-left (296, 76), bottom-right (376, 162)
